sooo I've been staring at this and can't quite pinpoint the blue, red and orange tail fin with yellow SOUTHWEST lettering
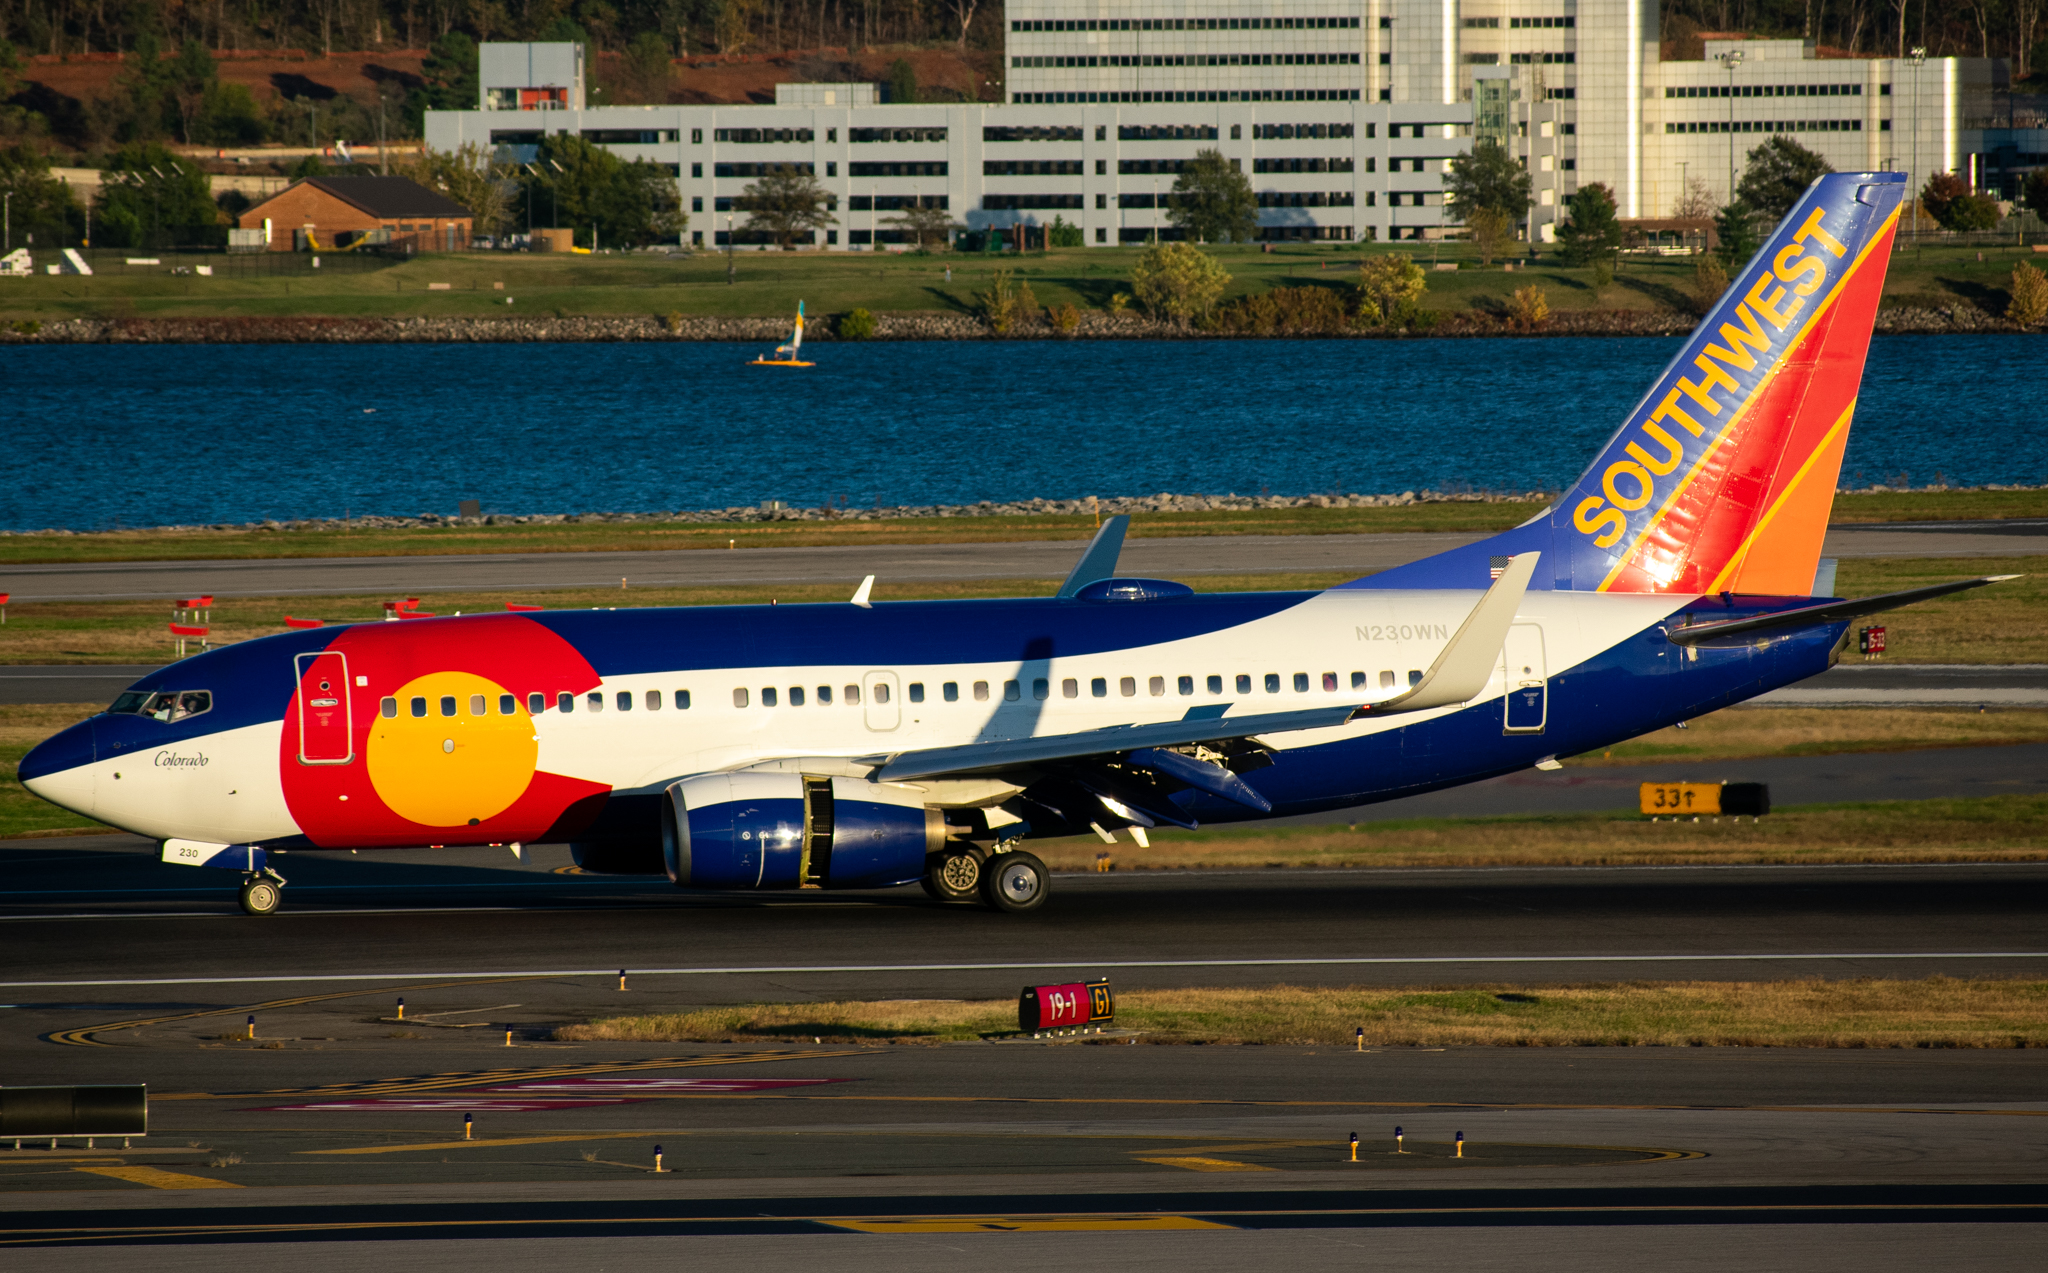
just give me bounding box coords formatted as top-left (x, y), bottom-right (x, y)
top-left (1360, 172), bottom-right (1907, 596)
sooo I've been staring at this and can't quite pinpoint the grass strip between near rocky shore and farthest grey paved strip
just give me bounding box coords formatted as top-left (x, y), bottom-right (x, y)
top-left (0, 489), bottom-right (2048, 565)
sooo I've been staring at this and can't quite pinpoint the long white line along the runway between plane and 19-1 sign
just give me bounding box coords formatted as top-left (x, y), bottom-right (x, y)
top-left (0, 950), bottom-right (2048, 991)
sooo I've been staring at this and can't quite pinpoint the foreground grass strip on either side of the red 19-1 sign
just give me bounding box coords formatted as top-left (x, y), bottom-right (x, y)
top-left (555, 976), bottom-right (2048, 1048)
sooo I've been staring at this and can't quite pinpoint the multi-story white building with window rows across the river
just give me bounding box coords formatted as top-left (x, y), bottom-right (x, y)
top-left (426, 17), bottom-right (1995, 248)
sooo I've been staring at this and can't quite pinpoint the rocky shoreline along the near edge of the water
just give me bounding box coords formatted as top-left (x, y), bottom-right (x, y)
top-left (0, 485), bottom-right (2048, 538)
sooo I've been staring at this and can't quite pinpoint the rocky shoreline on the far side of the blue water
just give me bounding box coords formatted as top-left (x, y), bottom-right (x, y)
top-left (0, 305), bottom-right (2021, 344)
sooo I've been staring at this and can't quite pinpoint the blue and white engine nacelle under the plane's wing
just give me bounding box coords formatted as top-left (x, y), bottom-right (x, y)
top-left (662, 774), bottom-right (946, 888)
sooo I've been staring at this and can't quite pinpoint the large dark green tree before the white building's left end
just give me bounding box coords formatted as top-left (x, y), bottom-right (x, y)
top-left (514, 133), bottom-right (688, 248)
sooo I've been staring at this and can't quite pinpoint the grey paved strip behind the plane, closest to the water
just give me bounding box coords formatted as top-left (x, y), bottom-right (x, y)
top-left (0, 522), bottom-right (2048, 602)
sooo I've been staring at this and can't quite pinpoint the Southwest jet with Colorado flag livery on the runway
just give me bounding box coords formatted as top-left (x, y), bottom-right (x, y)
top-left (20, 172), bottom-right (2015, 915)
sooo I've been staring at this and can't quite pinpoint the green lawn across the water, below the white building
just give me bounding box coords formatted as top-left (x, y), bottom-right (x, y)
top-left (0, 240), bottom-right (2038, 321)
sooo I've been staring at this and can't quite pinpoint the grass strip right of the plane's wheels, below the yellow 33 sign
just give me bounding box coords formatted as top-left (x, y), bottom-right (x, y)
top-left (1030, 794), bottom-right (2048, 872)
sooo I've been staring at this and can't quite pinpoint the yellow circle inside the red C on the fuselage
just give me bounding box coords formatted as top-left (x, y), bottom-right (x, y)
top-left (365, 671), bottom-right (541, 827)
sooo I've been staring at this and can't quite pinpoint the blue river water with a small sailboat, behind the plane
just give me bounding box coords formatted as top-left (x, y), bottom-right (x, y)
top-left (0, 336), bottom-right (2048, 530)
